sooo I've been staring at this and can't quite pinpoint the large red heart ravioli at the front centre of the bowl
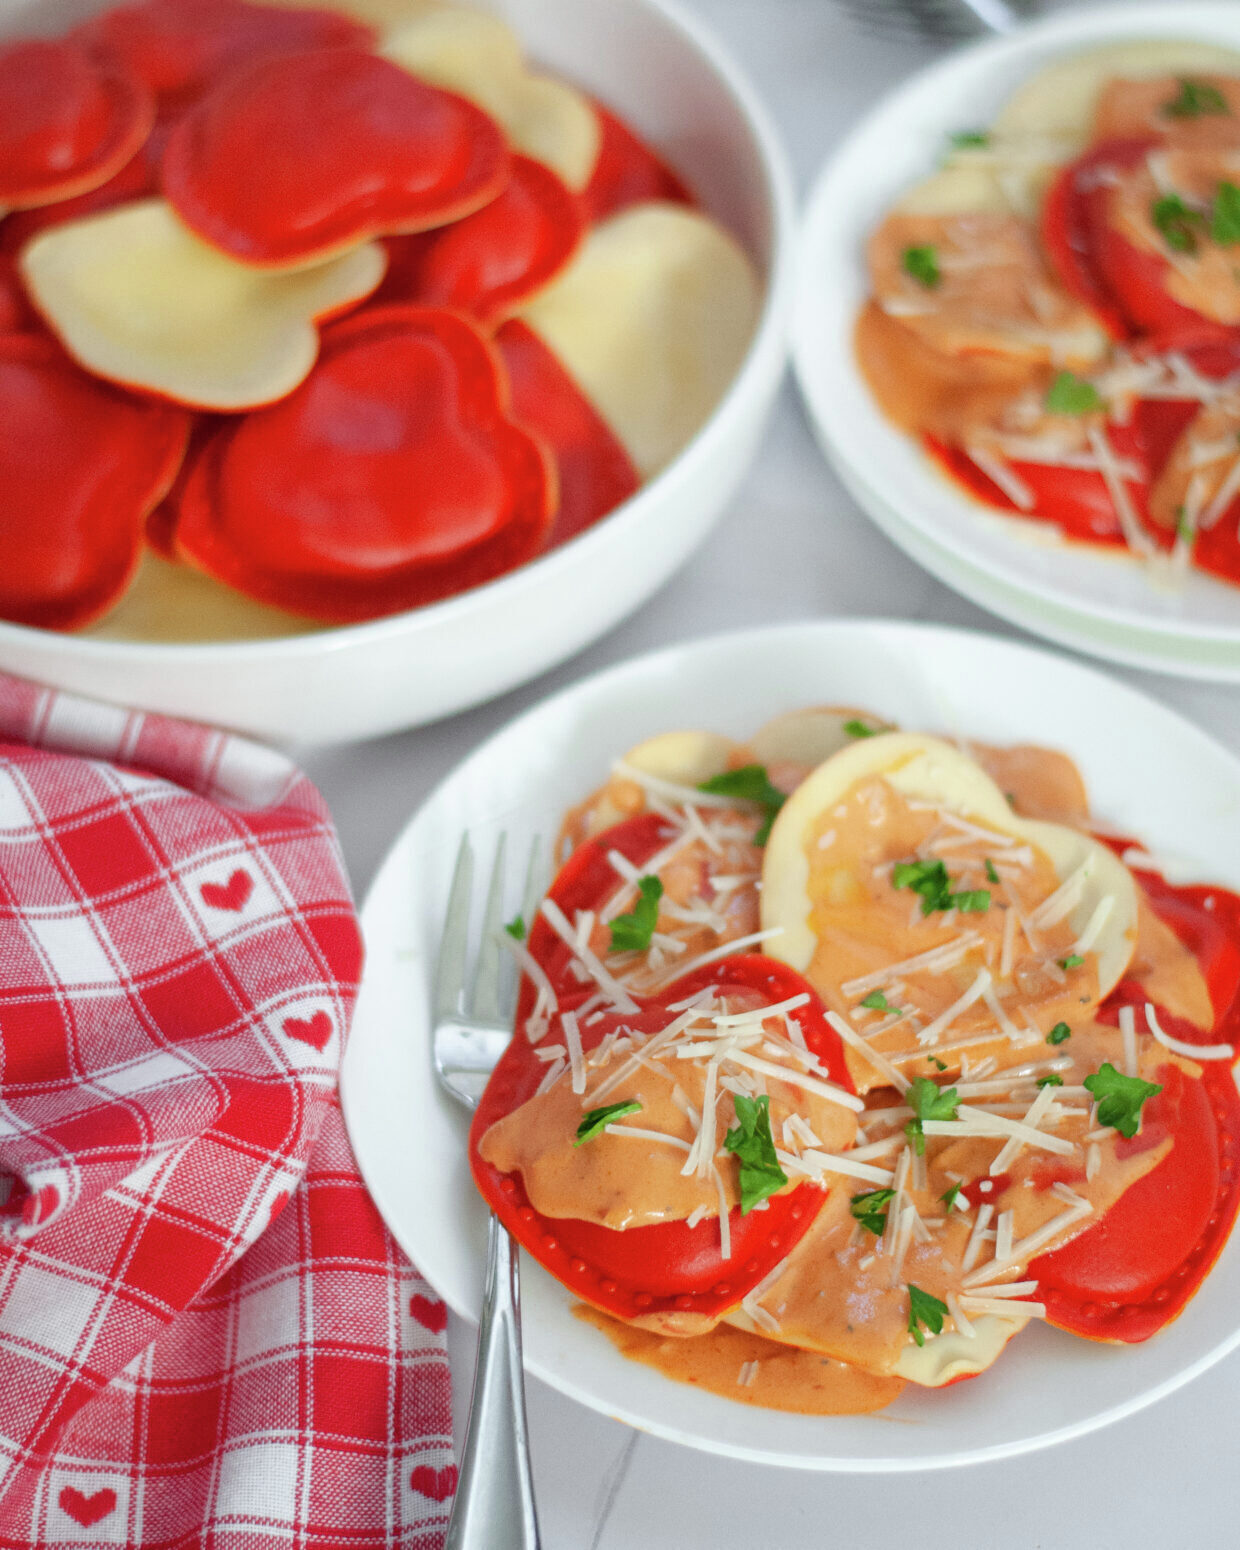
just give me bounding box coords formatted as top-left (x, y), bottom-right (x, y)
top-left (175, 307), bottom-right (555, 622)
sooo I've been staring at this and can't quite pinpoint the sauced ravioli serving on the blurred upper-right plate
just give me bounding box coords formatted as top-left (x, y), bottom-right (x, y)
top-left (856, 40), bottom-right (1240, 583)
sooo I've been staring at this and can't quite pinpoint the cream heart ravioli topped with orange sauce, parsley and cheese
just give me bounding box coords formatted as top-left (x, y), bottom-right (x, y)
top-left (761, 733), bottom-right (1138, 1090)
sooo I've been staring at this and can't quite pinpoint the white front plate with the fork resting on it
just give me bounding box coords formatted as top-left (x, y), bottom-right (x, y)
top-left (343, 622), bottom-right (1240, 1471)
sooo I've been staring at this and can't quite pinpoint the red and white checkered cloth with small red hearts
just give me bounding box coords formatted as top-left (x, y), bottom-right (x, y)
top-left (0, 676), bottom-right (456, 1550)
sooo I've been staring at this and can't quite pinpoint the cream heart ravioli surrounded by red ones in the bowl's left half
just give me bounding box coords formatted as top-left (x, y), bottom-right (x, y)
top-left (19, 200), bottom-right (388, 411)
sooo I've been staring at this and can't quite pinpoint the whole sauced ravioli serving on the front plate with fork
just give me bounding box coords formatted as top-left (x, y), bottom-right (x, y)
top-left (470, 708), bottom-right (1240, 1414)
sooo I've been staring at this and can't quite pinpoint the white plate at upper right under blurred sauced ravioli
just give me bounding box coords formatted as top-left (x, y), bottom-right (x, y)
top-left (794, 0), bottom-right (1240, 679)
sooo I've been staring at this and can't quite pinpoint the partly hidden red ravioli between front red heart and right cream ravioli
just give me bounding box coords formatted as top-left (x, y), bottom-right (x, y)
top-left (494, 318), bottom-right (642, 549)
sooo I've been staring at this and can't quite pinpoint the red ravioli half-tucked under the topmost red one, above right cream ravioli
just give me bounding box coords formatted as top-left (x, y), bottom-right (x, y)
top-left (378, 157), bottom-right (584, 324)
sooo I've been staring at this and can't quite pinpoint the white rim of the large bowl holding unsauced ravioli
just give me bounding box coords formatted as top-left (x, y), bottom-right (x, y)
top-left (0, 0), bottom-right (797, 668)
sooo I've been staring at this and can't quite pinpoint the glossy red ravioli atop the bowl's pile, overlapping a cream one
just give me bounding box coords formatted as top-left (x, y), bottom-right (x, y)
top-left (163, 48), bottom-right (508, 268)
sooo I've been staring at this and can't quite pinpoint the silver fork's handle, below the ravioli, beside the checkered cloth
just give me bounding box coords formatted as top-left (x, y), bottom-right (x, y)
top-left (443, 1215), bottom-right (539, 1550)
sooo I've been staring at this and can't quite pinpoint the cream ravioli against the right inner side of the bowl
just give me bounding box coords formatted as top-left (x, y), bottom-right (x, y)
top-left (522, 203), bottom-right (760, 477)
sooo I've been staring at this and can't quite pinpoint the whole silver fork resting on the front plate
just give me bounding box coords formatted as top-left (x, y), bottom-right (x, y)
top-left (432, 834), bottom-right (539, 1550)
